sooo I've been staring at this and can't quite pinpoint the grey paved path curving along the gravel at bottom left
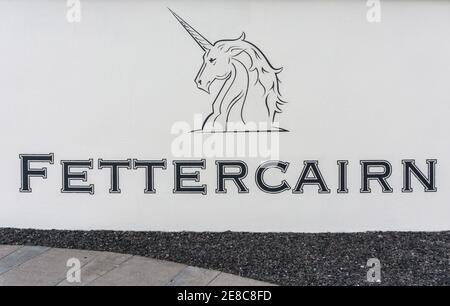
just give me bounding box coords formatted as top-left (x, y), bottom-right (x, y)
top-left (0, 245), bottom-right (269, 286)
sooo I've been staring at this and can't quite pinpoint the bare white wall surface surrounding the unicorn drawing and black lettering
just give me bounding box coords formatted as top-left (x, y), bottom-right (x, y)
top-left (0, 0), bottom-right (450, 232)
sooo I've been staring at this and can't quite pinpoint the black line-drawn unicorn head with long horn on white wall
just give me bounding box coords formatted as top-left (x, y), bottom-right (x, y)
top-left (169, 9), bottom-right (287, 132)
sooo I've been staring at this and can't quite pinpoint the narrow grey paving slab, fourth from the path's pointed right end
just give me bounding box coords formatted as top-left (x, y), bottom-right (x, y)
top-left (58, 252), bottom-right (132, 286)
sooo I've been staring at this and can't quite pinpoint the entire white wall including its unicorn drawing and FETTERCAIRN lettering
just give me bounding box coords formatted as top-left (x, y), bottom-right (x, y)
top-left (0, 1), bottom-right (450, 232)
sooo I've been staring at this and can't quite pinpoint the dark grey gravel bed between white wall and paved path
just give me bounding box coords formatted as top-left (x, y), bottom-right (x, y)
top-left (0, 228), bottom-right (450, 285)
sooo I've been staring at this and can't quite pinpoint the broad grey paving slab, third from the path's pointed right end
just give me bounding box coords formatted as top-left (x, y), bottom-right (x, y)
top-left (90, 256), bottom-right (186, 286)
